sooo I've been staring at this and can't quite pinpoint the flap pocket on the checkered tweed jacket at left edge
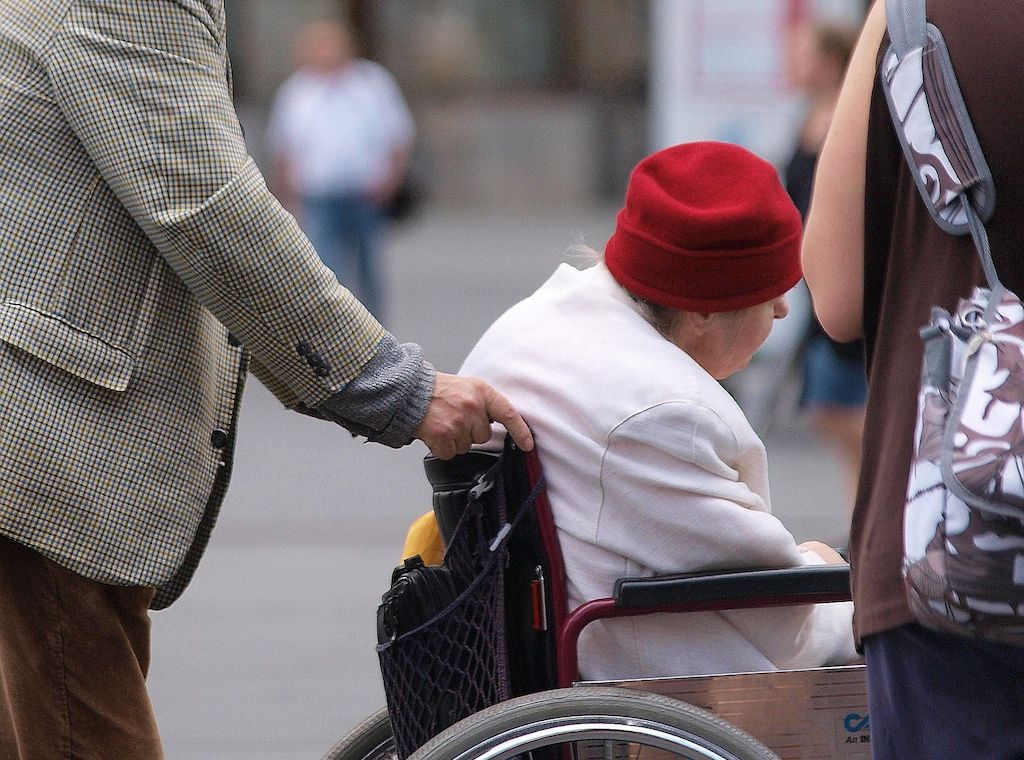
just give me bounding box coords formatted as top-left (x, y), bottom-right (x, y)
top-left (0, 301), bottom-right (135, 391)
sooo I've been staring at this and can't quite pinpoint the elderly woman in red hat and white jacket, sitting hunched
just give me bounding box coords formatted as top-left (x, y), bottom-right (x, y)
top-left (462, 142), bottom-right (856, 679)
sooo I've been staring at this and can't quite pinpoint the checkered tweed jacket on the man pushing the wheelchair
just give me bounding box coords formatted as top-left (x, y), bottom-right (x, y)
top-left (0, 0), bottom-right (386, 607)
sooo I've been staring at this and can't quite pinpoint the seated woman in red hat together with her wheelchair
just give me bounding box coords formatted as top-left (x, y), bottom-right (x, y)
top-left (329, 142), bottom-right (869, 760)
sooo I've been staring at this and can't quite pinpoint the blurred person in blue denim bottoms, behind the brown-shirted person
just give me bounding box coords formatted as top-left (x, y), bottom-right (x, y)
top-left (784, 24), bottom-right (867, 512)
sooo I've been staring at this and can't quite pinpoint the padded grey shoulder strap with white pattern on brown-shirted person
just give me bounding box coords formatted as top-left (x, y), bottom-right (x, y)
top-left (880, 0), bottom-right (997, 246)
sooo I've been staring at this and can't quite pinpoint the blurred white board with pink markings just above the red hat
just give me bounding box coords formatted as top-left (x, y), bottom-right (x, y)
top-left (649, 0), bottom-right (863, 163)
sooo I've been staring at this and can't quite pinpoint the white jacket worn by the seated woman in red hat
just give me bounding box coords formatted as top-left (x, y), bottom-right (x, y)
top-left (462, 264), bottom-right (856, 679)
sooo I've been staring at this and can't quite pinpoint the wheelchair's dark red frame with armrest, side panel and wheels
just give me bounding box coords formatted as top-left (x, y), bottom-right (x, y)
top-left (325, 447), bottom-right (870, 760)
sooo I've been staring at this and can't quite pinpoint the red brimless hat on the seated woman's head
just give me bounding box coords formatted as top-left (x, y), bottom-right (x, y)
top-left (604, 142), bottom-right (802, 312)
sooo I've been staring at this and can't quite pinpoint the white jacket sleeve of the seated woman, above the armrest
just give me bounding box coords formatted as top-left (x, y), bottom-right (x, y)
top-left (596, 400), bottom-right (802, 574)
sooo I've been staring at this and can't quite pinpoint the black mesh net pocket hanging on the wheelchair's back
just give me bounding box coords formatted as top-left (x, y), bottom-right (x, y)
top-left (377, 460), bottom-right (510, 758)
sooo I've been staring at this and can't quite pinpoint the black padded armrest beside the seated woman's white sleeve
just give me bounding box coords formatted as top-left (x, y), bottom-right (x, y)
top-left (612, 564), bottom-right (850, 609)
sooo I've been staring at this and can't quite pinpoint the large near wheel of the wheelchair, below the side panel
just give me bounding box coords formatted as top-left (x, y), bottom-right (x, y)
top-left (410, 686), bottom-right (779, 760)
